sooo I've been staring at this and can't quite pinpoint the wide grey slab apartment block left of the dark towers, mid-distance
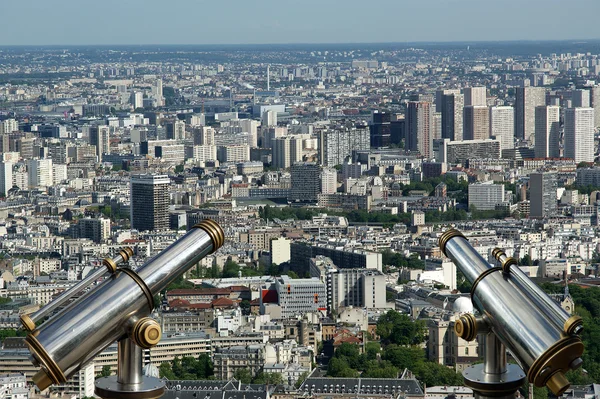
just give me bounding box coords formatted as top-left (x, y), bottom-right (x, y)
top-left (318, 126), bottom-right (371, 166)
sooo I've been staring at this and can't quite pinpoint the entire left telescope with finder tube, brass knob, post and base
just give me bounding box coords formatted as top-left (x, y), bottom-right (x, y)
top-left (22, 220), bottom-right (225, 399)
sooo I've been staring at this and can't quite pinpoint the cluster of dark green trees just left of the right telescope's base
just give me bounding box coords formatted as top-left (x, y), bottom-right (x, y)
top-left (327, 310), bottom-right (462, 386)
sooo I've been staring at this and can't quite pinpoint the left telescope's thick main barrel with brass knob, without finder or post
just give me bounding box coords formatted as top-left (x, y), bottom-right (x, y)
top-left (25, 220), bottom-right (224, 391)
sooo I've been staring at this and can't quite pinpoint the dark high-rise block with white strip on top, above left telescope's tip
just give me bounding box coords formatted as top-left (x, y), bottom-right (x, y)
top-left (130, 174), bottom-right (171, 231)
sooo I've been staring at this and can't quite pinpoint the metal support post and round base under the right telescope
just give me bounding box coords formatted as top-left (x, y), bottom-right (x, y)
top-left (463, 331), bottom-right (525, 399)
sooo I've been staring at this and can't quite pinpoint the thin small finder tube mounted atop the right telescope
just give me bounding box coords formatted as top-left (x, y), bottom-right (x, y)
top-left (492, 248), bottom-right (583, 335)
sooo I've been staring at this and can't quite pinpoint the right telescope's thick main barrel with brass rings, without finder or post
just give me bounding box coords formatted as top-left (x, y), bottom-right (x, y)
top-left (439, 229), bottom-right (583, 395)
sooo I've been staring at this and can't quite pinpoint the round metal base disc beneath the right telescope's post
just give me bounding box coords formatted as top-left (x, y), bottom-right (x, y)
top-left (463, 364), bottom-right (526, 399)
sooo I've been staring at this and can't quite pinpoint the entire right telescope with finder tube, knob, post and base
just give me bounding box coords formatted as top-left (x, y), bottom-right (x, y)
top-left (439, 229), bottom-right (583, 398)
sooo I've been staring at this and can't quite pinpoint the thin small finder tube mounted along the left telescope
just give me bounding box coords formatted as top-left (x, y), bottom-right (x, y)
top-left (21, 247), bottom-right (133, 331)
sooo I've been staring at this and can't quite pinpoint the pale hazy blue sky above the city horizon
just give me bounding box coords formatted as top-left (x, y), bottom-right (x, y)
top-left (0, 0), bottom-right (600, 45)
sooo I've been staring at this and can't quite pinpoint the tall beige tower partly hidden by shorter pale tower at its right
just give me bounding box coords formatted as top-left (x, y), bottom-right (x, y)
top-left (515, 87), bottom-right (546, 144)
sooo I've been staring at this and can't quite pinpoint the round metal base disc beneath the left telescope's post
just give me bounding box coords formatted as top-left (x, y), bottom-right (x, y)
top-left (94, 375), bottom-right (165, 399)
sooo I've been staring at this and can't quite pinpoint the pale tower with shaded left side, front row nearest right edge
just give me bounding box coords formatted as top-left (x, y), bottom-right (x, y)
top-left (565, 108), bottom-right (594, 163)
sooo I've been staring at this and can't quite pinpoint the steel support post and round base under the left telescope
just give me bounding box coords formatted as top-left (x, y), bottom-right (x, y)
top-left (95, 338), bottom-right (165, 399)
